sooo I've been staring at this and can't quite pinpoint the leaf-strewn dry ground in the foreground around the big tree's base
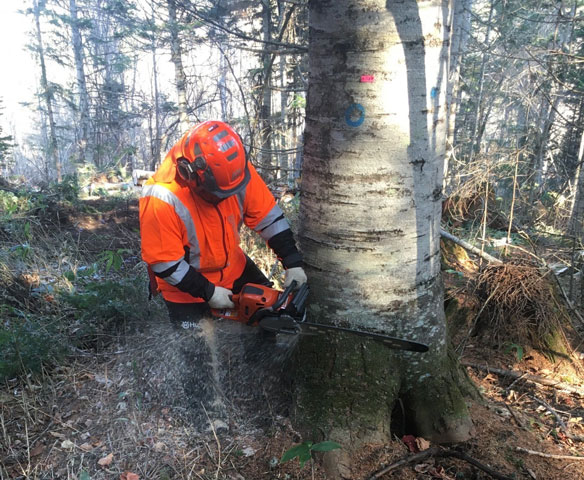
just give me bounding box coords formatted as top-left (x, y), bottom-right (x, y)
top-left (0, 338), bottom-right (584, 480)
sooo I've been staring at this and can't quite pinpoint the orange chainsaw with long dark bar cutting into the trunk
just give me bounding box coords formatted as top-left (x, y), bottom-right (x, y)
top-left (211, 282), bottom-right (428, 352)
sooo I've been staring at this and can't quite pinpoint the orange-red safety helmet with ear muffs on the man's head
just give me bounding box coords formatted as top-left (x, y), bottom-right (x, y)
top-left (177, 120), bottom-right (250, 199)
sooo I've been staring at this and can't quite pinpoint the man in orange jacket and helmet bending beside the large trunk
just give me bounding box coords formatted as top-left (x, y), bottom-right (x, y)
top-left (140, 120), bottom-right (306, 327)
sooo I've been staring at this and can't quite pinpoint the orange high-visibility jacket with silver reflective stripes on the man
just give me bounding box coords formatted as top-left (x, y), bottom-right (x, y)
top-left (140, 156), bottom-right (290, 303)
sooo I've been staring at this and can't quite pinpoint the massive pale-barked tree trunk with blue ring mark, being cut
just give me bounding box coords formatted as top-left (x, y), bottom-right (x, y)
top-left (295, 0), bottom-right (472, 476)
